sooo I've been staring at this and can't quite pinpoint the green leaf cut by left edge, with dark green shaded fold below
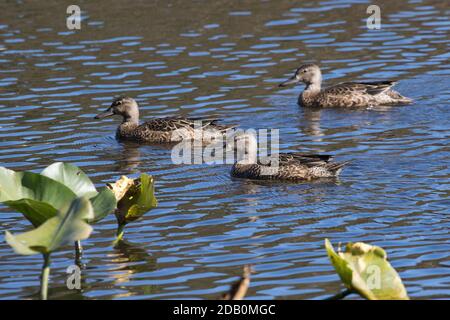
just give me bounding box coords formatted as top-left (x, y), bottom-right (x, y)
top-left (0, 167), bottom-right (76, 227)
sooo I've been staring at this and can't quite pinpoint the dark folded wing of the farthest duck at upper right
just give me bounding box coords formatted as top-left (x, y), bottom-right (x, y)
top-left (323, 81), bottom-right (396, 96)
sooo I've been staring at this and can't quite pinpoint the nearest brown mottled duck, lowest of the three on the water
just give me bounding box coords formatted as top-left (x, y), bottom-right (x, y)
top-left (231, 133), bottom-right (349, 181)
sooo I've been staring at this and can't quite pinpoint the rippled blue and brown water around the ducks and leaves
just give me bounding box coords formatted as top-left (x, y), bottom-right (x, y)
top-left (0, 0), bottom-right (450, 299)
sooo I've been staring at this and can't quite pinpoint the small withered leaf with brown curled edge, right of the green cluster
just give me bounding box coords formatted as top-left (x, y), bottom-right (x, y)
top-left (115, 173), bottom-right (158, 226)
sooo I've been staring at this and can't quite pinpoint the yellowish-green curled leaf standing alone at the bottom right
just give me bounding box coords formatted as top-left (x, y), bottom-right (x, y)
top-left (325, 239), bottom-right (409, 300)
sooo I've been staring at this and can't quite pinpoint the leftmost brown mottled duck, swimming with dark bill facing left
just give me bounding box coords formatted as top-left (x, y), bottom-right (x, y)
top-left (94, 96), bottom-right (235, 143)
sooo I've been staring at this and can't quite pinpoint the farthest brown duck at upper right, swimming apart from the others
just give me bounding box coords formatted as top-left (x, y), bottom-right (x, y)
top-left (279, 63), bottom-right (412, 108)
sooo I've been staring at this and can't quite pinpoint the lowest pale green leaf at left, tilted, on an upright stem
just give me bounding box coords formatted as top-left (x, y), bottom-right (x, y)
top-left (5, 198), bottom-right (94, 255)
